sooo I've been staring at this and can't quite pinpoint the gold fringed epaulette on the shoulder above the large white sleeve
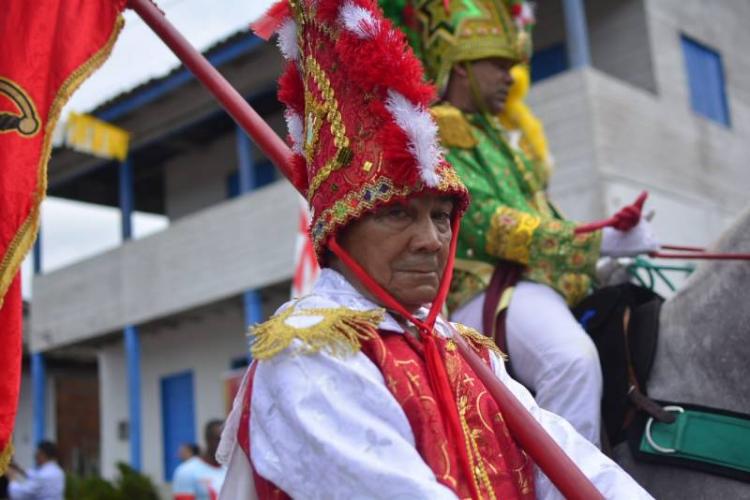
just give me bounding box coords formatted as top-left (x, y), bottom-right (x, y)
top-left (250, 306), bottom-right (385, 360)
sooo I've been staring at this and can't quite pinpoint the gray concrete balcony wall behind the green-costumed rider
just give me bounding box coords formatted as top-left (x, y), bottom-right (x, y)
top-left (531, 63), bottom-right (750, 249)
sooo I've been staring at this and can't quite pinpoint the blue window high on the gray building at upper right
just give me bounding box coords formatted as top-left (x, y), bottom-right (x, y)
top-left (682, 35), bottom-right (730, 127)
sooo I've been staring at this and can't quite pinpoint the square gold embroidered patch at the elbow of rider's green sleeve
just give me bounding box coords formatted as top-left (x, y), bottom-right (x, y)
top-left (486, 206), bottom-right (541, 265)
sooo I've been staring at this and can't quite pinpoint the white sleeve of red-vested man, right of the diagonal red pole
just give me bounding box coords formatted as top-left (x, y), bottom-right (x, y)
top-left (492, 353), bottom-right (653, 500)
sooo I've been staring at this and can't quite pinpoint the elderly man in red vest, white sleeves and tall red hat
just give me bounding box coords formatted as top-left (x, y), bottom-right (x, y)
top-left (218, 0), bottom-right (649, 499)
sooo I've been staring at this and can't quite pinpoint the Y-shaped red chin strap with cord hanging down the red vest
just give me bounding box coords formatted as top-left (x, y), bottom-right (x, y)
top-left (328, 214), bottom-right (480, 498)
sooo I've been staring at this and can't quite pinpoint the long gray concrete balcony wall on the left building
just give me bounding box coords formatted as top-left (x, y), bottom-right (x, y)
top-left (31, 182), bottom-right (299, 351)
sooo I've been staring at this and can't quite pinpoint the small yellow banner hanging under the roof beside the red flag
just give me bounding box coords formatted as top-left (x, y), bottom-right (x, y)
top-left (65, 113), bottom-right (130, 161)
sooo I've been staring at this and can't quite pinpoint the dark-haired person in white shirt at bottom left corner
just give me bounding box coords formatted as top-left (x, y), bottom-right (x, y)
top-left (7, 441), bottom-right (65, 500)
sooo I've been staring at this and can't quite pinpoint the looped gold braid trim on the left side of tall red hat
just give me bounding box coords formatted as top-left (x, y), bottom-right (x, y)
top-left (305, 56), bottom-right (352, 200)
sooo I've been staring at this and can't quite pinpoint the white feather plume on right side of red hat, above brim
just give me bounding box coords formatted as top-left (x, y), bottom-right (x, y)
top-left (385, 90), bottom-right (442, 187)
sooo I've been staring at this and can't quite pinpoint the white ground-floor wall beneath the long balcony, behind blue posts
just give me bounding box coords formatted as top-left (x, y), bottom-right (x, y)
top-left (99, 299), bottom-right (247, 483)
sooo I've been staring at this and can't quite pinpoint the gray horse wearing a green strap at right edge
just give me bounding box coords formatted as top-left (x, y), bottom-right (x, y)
top-left (613, 205), bottom-right (750, 499)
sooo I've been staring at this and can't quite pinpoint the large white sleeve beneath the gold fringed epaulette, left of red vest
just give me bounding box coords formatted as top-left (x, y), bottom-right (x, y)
top-left (250, 345), bottom-right (456, 500)
